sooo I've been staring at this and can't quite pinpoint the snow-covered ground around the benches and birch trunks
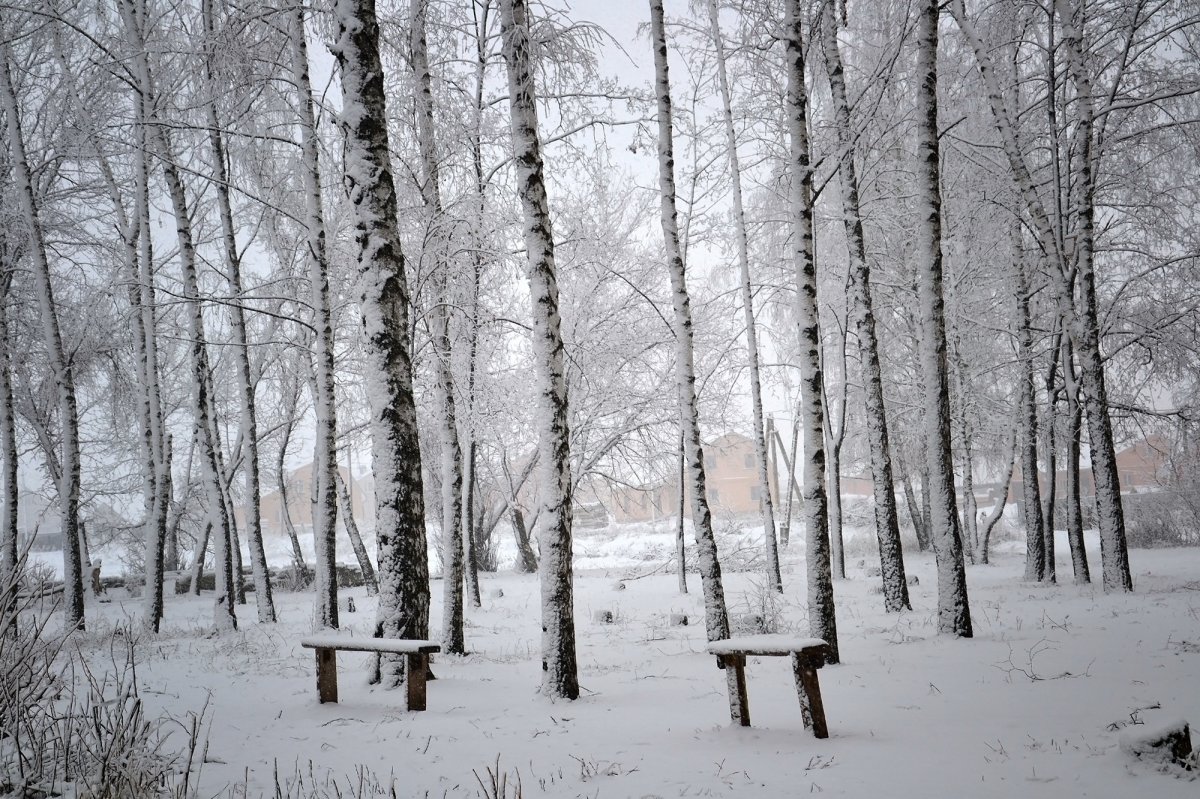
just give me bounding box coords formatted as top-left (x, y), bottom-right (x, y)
top-left (42, 539), bottom-right (1200, 799)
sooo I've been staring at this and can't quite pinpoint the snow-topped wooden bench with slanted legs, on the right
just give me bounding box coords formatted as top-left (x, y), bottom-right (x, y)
top-left (708, 635), bottom-right (829, 738)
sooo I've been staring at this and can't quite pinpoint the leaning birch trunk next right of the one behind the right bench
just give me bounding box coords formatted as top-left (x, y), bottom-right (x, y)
top-left (821, 4), bottom-right (912, 612)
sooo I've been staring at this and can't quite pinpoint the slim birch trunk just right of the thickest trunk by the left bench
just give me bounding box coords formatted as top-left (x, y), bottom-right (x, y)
top-left (409, 0), bottom-right (468, 655)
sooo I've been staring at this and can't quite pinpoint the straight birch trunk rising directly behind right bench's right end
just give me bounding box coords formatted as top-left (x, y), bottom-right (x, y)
top-left (784, 0), bottom-right (841, 663)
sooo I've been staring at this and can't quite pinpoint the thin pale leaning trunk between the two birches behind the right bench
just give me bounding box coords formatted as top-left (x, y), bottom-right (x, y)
top-left (708, 0), bottom-right (782, 590)
